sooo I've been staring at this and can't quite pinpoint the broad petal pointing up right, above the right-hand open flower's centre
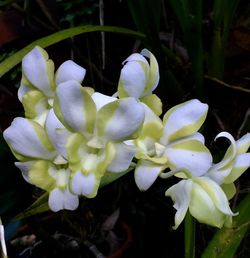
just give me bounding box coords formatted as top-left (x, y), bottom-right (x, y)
top-left (161, 99), bottom-right (208, 145)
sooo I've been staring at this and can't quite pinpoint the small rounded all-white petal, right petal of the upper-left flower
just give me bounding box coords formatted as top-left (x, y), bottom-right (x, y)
top-left (55, 60), bottom-right (86, 85)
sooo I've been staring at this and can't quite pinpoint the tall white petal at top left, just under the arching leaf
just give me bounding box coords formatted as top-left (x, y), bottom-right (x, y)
top-left (22, 46), bottom-right (55, 97)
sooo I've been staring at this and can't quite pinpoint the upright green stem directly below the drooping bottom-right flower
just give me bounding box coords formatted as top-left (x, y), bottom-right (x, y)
top-left (184, 212), bottom-right (195, 258)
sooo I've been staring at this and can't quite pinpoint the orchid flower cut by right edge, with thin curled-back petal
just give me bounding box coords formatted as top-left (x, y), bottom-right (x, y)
top-left (207, 132), bottom-right (250, 199)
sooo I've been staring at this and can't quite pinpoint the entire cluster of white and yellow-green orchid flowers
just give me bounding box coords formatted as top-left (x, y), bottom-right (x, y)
top-left (4, 46), bottom-right (250, 228)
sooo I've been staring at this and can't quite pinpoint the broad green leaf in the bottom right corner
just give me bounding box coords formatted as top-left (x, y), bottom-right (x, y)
top-left (202, 194), bottom-right (250, 258)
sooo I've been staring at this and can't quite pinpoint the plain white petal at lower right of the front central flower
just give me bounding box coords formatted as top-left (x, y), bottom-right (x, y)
top-left (107, 143), bottom-right (136, 172)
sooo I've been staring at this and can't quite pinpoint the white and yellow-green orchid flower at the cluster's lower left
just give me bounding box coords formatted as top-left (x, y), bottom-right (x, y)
top-left (3, 116), bottom-right (79, 211)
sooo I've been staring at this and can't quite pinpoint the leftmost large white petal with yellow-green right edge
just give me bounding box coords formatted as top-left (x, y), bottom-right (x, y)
top-left (3, 117), bottom-right (56, 160)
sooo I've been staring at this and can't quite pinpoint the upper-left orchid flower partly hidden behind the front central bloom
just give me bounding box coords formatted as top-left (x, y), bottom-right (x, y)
top-left (18, 46), bottom-right (86, 125)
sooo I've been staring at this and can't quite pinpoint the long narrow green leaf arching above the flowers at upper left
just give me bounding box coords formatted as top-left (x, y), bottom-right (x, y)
top-left (0, 25), bottom-right (145, 77)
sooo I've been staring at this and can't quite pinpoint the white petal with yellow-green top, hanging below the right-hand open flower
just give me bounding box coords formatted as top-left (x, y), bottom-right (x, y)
top-left (135, 160), bottom-right (163, 191)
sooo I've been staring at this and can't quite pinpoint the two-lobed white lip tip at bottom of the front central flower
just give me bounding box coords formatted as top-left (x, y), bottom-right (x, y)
top-left (71, 172), bottom-right (99, 198)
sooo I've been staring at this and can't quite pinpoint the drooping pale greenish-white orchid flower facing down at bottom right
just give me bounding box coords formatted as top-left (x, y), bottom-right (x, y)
top-left (165, 176), bottom-right (237, 229)
